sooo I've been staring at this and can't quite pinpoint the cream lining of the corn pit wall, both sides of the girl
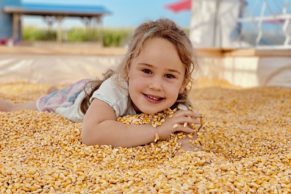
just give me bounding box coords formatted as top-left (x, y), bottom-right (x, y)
top-left (0, 54), bottom-right (291, 87)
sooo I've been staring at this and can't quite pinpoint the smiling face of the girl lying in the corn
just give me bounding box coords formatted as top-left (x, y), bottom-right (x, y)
top-left (128, 38), bottom-right (185, 114)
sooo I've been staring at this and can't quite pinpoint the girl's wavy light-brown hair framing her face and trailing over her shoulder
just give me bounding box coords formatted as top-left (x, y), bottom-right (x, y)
top-left (81, 19), bottom-right (197, 113)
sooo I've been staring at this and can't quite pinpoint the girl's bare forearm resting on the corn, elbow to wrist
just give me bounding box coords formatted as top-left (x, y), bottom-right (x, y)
top-left (81, 120), bottom-right (157, 147)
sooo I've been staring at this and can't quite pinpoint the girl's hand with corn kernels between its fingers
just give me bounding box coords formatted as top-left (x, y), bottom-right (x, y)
top-left (157, 110), bottom-right (201, 140)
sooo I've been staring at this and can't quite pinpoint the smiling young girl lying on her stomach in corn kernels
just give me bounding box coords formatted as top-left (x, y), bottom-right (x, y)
top-left (0, 19), bottom-right (199, 147)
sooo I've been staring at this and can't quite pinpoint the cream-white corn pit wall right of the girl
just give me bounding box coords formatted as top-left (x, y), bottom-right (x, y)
top-left (194, 56), bottom-right (291, 87)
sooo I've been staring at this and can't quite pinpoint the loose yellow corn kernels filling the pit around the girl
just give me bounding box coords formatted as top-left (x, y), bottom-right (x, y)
top-left (0, 83), bottom-right (291, 193)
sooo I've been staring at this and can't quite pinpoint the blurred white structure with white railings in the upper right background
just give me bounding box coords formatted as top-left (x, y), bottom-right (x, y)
top-left (190, 0), bottom-right (291, 48)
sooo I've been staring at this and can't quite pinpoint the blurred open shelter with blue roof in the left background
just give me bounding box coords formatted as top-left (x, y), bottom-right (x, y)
top-left (0, 0), bottom-right (110, 41)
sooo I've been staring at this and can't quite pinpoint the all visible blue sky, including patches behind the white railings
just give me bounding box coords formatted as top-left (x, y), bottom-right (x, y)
top-left (22, 0), bottom-right (291, 28)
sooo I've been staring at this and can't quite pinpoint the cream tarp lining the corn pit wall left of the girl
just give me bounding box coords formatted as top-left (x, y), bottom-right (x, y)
top-left (0, 54), bottom-right (120, 84)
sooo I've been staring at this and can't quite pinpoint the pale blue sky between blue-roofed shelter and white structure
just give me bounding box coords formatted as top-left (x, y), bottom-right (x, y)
top-left (22, 0), bottom-right (191, 27)
